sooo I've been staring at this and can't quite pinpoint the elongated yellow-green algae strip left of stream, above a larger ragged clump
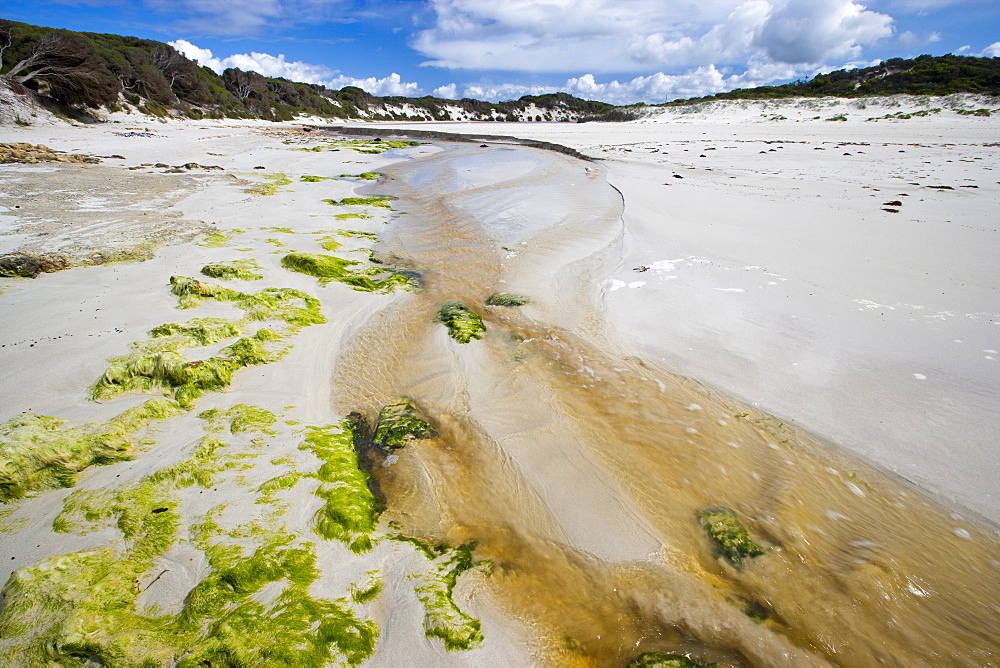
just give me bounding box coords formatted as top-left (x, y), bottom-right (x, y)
top-left (170, 276), bottom-right (326, 329)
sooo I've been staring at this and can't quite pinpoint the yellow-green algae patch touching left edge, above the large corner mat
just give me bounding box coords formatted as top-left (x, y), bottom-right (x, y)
top-left (0, 399), bottom-right (180, 503)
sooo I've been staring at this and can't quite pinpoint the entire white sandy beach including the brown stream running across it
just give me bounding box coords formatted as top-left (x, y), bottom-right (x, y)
top-left (0, 100), bottom-right (1000, 666)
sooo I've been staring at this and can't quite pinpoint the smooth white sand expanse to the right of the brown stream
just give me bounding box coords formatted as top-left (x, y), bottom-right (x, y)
top-left (362, 99), bottom-right (1000, 521)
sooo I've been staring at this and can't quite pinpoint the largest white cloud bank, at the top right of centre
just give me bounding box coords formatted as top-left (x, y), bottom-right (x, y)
top-left (412, 0), bottom-right (893, 73)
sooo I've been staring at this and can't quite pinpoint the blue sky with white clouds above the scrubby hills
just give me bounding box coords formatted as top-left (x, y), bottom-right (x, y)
top-left (0, 0), bottom-right (1000, 104)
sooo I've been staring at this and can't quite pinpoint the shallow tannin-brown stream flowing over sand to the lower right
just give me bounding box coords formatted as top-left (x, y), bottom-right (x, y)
top-left (333, 138), bottom-right (1000, 666)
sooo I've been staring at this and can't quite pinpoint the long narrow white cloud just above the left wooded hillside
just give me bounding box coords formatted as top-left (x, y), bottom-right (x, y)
top-left (169, 39), bottom-right (422, 95)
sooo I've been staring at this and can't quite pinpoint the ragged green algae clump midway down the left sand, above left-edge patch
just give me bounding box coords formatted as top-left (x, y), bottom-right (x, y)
top-left (91, 329), bottom-right (278, 408)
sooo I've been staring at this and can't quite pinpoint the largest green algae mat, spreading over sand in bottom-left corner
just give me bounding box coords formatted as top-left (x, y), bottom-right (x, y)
top-left (0, 420), bottom-right (378, 667)
